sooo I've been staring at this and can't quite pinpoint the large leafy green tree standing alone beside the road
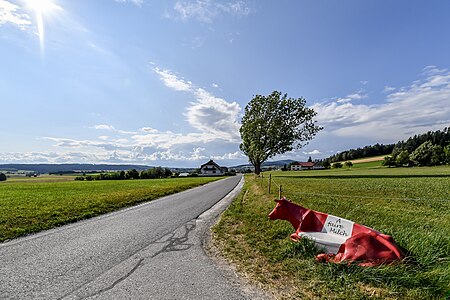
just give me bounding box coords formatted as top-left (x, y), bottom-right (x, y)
top-left (240, 91), bottom-right (322, 174)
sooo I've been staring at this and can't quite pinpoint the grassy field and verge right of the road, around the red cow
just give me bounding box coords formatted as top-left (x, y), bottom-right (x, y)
top-left (214, 162), bottom-right (450, 299)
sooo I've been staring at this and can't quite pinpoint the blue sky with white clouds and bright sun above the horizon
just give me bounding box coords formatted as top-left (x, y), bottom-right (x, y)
top-left (0, 0), bottom-right (450, 167)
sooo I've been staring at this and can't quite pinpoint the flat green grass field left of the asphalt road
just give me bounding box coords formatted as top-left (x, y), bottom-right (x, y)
top-left (0, 176), bottom-right (220, 242)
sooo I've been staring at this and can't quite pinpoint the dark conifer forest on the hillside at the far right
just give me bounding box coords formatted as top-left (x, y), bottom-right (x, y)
top-left (325, 127), bottom-right (450, 163)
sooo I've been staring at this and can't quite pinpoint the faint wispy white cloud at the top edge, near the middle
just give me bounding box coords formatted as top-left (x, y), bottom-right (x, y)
top-left (173, 0), bottom-right (250, 23)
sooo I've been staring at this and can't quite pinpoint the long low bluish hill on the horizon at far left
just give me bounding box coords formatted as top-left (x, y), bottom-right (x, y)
top-left (0, 164), bottom-right (152, 173)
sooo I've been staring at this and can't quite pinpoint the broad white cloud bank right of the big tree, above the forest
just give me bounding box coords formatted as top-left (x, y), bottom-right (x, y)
top-left (313, 68), bottom-right (450, 142)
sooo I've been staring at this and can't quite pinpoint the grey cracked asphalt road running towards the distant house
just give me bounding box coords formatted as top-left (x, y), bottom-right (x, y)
top-left (0, 176), bottom-right (250, 299)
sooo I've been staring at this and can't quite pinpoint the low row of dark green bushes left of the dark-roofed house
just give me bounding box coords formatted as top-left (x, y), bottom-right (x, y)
top-left (75, 167), bottom-right (174, 181)
